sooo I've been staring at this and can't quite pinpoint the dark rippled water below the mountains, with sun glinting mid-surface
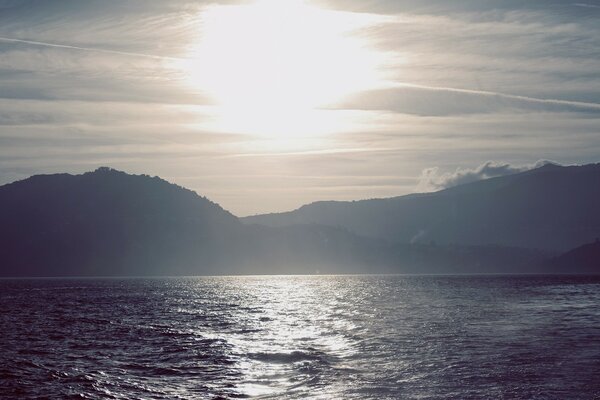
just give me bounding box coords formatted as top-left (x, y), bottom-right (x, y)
top-left (0, 276), bottom-right (600, 399)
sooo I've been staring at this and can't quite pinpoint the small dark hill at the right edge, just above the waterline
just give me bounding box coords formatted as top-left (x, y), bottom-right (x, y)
top-left (544, 239), bottom-right (600, 274)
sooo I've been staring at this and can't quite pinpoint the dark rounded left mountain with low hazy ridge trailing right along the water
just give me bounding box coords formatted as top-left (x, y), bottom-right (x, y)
top-left (0, 168), bottom-right (548, 276)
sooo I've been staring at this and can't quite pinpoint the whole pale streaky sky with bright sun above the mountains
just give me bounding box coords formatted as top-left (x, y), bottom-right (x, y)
top-left (0, 0), bottom-right (600, 216)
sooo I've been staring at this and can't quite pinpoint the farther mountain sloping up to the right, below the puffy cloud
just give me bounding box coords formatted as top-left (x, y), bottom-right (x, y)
top-left (242, 164), bottom-right (600, 252)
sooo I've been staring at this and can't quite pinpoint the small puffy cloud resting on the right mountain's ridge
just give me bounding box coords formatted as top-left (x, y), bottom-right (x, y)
top-left (417, 160), bottom-right (558, 192)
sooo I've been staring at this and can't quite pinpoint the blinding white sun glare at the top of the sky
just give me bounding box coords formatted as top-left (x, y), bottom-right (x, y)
top-left (176, 0), bottom-right (380, 136)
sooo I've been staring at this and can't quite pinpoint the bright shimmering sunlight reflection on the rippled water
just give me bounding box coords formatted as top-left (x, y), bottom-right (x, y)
top-left (190, 276), bottom-right (359, 397)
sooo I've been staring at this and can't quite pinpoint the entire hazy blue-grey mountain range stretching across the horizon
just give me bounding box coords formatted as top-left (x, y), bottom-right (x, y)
top-left (0, 165), bottom-right (600, 276)
